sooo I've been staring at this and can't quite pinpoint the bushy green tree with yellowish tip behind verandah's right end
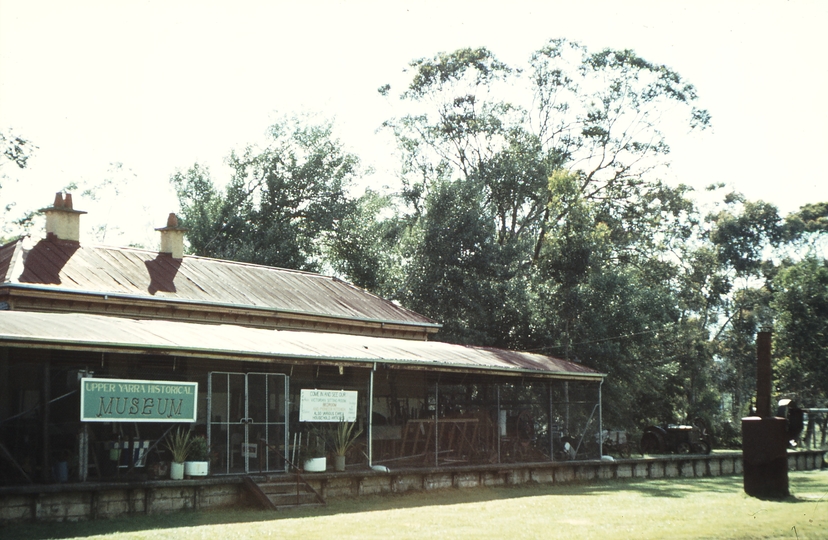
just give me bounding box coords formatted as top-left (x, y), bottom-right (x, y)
top-left (535, 169), bottom-right (717, 429)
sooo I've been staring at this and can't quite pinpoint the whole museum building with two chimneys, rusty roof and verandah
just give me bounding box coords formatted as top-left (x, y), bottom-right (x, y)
top-left (0, 194), bottom-right (603, 485)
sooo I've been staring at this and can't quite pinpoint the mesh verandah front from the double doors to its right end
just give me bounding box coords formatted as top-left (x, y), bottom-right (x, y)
top-left (200, 363), bottom-right (602, 474)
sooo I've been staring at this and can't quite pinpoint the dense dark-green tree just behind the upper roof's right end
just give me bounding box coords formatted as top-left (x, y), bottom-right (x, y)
top-left (404, 180), bottom-right (525, 347)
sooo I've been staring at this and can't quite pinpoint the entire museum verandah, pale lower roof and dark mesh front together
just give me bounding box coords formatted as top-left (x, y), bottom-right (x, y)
top-left (0, 311), bottom-right (603, 483)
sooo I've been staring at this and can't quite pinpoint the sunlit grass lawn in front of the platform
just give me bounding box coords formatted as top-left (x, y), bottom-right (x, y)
top-left (0, 471), bottom-right (828, 540)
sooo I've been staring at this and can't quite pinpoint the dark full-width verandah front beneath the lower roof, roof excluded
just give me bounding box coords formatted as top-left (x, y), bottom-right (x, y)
top-left (0, 348), bottom-right (601, 485)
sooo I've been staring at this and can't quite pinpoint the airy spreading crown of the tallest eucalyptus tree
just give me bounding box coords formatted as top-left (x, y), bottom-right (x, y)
top-left (381, 40), bottom-right (709, 260)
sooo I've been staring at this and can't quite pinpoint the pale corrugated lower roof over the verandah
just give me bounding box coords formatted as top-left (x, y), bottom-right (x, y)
top-left (0, 311), bottom-right (602, 379)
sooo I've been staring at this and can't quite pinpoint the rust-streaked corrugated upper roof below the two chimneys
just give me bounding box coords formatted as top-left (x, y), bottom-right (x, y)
top-left (0, 239), bottom-right (440, 331)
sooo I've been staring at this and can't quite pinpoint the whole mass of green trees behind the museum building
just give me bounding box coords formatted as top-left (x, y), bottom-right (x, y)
top-left (163, 40), bottom-right (828, 438)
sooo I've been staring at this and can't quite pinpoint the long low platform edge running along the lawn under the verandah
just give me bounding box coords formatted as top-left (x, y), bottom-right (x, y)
top-left (0, 450), bottom-right (826, 523)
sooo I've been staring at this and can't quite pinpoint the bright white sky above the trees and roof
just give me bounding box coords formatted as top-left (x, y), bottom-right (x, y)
top-left (0, 0), bottom-right (828, 247)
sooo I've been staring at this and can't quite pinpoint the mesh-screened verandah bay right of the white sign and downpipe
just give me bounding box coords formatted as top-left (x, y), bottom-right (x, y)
top-left (369, 367), bottom-right (602, 469)
